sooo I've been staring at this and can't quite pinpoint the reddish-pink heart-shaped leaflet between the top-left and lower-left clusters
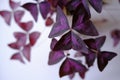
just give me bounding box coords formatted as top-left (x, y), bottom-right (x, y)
top-left (19, 21), bottom-right (33, 32)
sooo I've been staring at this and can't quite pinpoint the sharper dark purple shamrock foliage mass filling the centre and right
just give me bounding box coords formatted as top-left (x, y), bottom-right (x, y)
top-left (48, 0), bottom-right (117, 79)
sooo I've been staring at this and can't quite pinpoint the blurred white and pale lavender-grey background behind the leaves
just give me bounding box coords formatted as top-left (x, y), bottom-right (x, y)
top-left (0, 0), bottom-right (120, 80)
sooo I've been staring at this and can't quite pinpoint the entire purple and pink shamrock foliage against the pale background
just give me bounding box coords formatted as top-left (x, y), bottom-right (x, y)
top-left (0, 0), bottom-right (120, 79)
